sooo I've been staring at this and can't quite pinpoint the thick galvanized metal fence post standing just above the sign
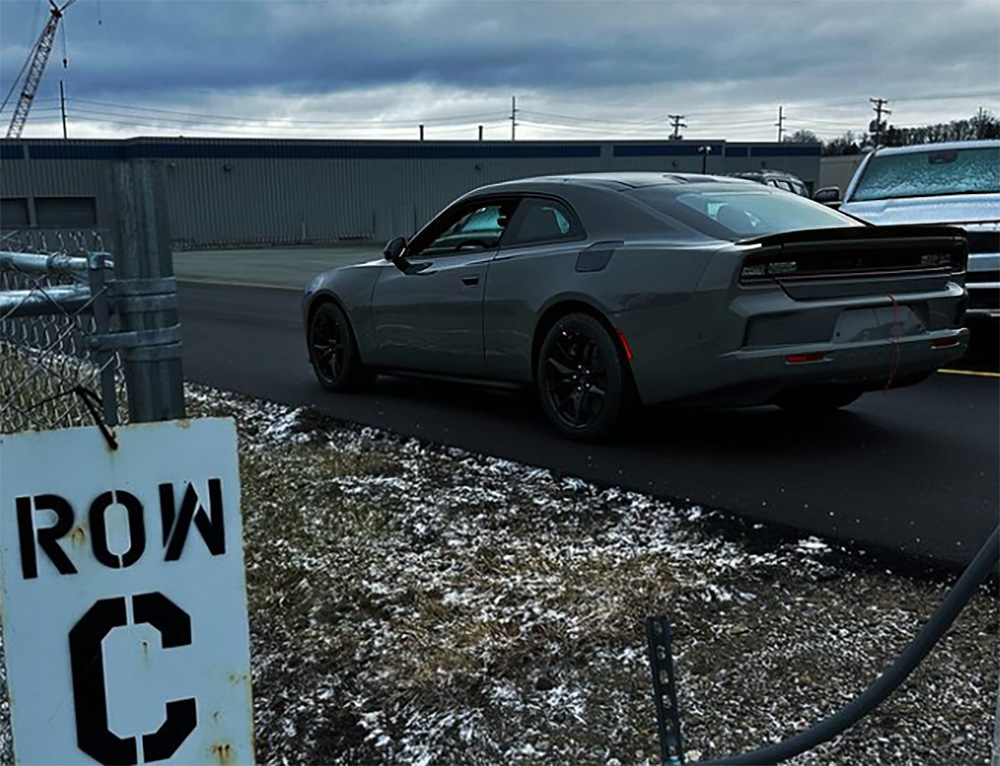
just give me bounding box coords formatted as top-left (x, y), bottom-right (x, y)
top-left (111, 160), bottom-right (184, 423)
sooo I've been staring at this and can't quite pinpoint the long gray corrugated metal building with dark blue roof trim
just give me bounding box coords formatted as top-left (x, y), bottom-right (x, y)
top-left (0, 138), bottom-right (820, 248)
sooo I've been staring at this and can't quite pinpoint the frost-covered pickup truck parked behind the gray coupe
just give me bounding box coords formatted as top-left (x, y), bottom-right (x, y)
top-left (832, 141), bottom-right (1000, 317)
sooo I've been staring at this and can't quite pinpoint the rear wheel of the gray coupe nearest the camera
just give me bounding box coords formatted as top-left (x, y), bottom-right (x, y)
top-left (535, 314), bottom-right (630, 440)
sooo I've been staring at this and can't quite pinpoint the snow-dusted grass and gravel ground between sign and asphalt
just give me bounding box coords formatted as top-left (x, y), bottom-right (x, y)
top-left (1, 387), bottom-right (1000, 766)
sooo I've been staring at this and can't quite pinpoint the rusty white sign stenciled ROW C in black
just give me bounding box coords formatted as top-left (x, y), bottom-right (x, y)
top-left (0, 419), bottom-right (254, 764)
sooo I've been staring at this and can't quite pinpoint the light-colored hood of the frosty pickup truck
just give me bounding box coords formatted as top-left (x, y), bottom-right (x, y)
top-left (840, 194), bottom-right (1000, 225)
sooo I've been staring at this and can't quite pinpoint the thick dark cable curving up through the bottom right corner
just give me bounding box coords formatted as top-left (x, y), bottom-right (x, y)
top-left (698, 526), bottom-right (1000, 766)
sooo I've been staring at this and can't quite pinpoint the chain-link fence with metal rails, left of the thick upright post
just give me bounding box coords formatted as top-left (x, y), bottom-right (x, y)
top-left (0, 231), bottom-right (127, 433)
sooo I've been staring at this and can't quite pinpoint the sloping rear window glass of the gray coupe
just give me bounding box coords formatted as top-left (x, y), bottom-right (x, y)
top-left (632, 186), bottom-right (864, 241)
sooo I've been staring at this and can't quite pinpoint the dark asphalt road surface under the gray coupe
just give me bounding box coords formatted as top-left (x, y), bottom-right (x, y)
top-left (180, 283), bottom-right (1000, 563)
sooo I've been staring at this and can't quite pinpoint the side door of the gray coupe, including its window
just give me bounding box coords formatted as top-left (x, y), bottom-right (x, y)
top-left (372, 198), bottom-right (517, 376)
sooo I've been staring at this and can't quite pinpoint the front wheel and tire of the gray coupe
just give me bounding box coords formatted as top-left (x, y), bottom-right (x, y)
top-left (307, 301), bottom-right (375, 393)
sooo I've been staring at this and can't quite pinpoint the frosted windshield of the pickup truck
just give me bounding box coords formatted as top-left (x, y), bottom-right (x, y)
top-left (850, 147), bottom-right (1000, 202)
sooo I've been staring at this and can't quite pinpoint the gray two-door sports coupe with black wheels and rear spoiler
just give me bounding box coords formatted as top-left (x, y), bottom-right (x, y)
top-left (303, 173), bottom-right (968, 438)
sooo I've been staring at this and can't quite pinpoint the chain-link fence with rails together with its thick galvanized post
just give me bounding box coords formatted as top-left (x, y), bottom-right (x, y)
top-left (0, 160), bottom-right (184, 433)
